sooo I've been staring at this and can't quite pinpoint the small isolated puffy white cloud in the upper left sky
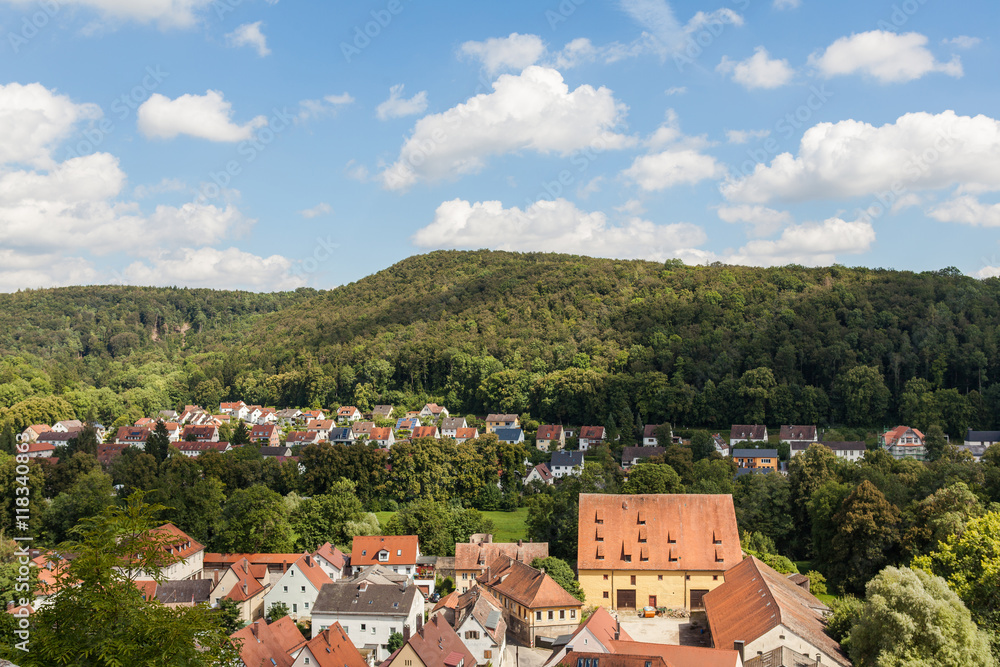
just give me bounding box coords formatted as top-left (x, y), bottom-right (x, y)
top-left (138, 90), bottom-right (267, 142)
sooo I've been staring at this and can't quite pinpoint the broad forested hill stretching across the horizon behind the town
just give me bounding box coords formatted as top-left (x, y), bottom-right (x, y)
top-left (0, 251), bottom-right (1000, 435)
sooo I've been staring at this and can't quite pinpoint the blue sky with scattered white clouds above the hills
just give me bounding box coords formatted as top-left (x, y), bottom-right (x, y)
top-left (0, 0), bottom-right (1000, 291)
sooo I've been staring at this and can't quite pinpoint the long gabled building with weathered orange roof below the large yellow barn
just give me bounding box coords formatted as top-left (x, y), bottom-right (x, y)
top-left (705, 556), bottom-right (851, 667)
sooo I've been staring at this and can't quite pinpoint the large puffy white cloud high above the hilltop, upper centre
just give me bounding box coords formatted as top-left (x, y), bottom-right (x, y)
top-left (381, 66), bottom-right (635, 190)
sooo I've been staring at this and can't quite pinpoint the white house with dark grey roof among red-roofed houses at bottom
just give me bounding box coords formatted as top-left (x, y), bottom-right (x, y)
top-left (312, 573), bottom-right (424, 662)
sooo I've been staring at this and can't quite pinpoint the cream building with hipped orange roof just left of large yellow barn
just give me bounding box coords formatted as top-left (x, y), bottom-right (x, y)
top-left (478, 556), bottom-right (583, 647)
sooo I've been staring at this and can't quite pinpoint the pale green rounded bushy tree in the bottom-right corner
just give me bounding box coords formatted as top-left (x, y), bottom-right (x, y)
top-left (847, 567), bottom-right (996, 667)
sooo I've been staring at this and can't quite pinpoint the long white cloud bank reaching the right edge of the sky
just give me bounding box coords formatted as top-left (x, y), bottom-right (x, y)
top-left (722, 111), bottom-right (1000, 204)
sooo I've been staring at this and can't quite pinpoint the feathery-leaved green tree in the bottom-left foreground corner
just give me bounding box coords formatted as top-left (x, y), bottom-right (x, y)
top-left (0, 494), bottom-right (239, 667)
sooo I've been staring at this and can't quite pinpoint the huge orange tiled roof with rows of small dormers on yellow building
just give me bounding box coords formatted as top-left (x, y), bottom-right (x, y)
top-left (577, 493), bottom-right (743, 572)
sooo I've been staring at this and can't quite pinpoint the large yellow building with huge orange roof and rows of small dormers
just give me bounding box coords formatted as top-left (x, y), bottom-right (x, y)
top-left (577, 493), bottom-right (743, 609)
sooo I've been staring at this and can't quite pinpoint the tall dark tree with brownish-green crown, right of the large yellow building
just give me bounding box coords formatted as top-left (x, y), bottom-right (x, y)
top-left (830, 480), bottom-right (900, 592)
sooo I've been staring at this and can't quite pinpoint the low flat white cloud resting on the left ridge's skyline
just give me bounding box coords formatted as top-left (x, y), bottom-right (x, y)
top-left (121, 248), bottom-right (306, 291)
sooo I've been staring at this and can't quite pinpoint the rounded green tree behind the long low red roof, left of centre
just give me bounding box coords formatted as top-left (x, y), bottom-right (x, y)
top-left (215, 485), bottom-right (293, 553)
